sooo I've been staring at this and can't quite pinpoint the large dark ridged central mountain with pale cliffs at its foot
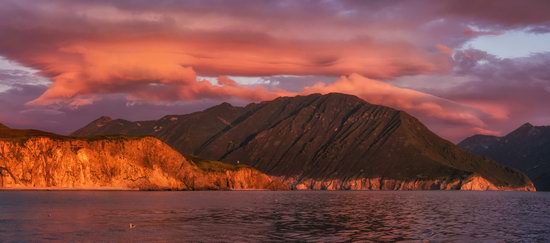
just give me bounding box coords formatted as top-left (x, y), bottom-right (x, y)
top-left (73, 93), bottom-right (532, 190)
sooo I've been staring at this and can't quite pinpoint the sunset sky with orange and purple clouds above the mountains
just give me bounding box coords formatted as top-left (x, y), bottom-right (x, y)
top-left (0, 0), bottom-right (550, 142)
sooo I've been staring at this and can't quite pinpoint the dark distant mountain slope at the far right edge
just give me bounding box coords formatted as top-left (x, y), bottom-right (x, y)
top-left (459, 123), bottom-right (550, 191)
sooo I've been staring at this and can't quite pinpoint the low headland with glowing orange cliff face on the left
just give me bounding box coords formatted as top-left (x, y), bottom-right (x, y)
top-left (0, 125), bottom-right (288, 190)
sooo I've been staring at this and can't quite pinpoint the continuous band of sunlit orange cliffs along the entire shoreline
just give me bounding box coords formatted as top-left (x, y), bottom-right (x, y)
top-left (0, 122), bottom-right (535, 191)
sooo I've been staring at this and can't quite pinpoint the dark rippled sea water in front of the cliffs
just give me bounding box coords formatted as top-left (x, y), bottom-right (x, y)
top-left (0, 191), bottom-right (550, 242)
